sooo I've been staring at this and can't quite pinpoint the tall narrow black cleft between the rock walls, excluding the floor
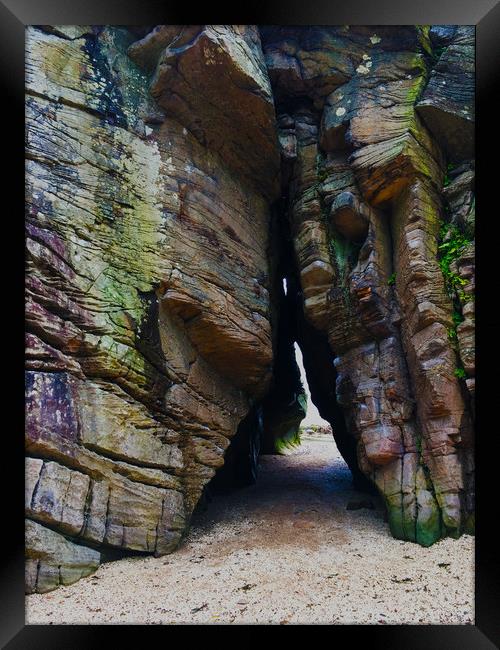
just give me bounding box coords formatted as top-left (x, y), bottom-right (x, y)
top-left (198, 147), bottom-right (377, 502)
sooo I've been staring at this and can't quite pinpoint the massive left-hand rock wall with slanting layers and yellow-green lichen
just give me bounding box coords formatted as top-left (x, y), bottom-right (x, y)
top-left (26, 27), bottom-right (279, 591)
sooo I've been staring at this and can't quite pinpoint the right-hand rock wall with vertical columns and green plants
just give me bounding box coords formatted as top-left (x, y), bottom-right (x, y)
top-left (262, 26), bottom-right (474, 545)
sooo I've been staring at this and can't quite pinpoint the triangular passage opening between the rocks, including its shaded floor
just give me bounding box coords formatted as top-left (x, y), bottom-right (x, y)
top-left (188, 274), bottom-right (384, 548)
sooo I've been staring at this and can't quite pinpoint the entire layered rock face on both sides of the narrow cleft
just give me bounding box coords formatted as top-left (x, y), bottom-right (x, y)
top-left (26, 25), bottom-right (475, 592)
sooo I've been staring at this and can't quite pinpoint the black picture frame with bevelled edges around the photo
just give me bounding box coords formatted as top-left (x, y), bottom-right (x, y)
top-left (4, 0), bottom-right (500, 650)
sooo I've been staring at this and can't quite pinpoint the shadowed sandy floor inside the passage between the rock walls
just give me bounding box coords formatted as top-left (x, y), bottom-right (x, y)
top-left (188, 432), bottom-right (385, 548)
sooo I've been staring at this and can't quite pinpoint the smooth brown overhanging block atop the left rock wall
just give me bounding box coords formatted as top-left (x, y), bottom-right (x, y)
top-left (142, 25), bottom-right (279, 198)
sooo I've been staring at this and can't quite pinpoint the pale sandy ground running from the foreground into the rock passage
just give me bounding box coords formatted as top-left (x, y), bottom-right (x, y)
top-left (26, 436), bottom-right (474, 624)
